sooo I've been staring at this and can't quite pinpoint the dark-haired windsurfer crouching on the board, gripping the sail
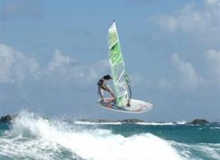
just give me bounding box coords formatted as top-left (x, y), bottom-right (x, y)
top-left (98, 75), bottom-right (116, 101)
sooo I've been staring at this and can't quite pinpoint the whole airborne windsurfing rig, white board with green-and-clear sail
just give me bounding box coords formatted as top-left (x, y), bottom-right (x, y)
top-left (97, 21), bottom-right (153, 113)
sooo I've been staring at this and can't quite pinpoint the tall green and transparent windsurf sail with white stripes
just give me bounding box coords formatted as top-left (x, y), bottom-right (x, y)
top-left (108, 21), bottom-right (131, 106)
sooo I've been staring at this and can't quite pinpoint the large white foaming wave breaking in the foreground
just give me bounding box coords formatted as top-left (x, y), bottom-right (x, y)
top-left (0, 112), bottom-right (189, 160)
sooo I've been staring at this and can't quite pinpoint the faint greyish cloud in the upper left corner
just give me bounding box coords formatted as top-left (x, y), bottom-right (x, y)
top-left (1, 0), bottom-right (42, 19)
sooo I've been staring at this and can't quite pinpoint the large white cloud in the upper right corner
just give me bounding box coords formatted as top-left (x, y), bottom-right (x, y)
top-left (154, 0), bottom-right (220, 39)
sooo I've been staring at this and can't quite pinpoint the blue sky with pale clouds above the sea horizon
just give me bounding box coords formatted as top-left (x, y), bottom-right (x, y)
top-left (0, 0), bottom-right (220, 122)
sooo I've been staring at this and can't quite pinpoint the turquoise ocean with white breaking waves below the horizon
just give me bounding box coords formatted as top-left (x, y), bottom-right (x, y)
top-left (0, 112), bottom-right (220, 160)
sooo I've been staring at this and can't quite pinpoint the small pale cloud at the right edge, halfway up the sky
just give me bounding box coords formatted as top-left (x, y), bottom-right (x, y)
top-left (206, 50), bottom-right (220, 85)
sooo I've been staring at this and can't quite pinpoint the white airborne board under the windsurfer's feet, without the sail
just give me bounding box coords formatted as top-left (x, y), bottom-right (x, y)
top-left (97, 97), bottom-right (153, 113)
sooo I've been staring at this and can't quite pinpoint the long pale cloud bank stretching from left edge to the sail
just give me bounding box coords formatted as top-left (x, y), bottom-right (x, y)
top-left (0, 44), bottom-right (110, 85)
